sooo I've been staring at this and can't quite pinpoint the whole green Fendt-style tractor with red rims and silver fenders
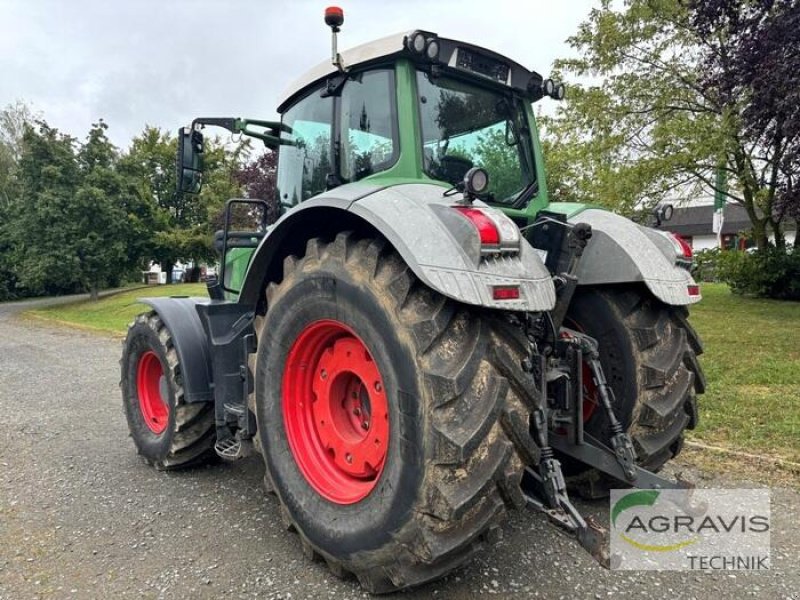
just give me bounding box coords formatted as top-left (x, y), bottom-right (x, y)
top-left (121, 8), bottom-right (705, 593)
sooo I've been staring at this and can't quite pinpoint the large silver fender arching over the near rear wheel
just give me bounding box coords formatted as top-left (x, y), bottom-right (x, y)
top-left (240, 183), bottom-right (555, 311)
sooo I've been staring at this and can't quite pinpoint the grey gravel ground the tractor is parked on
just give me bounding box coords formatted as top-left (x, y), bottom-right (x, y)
top-left (0, 305), bottom-right (800, 600)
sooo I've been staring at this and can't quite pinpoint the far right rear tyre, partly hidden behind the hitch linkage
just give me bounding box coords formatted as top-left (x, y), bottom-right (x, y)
top-left (564, 286), bottom-right (705, 497)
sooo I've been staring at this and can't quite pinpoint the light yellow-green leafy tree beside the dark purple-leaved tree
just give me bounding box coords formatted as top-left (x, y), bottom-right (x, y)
top-left (542, 0), bottom-right (796, 248)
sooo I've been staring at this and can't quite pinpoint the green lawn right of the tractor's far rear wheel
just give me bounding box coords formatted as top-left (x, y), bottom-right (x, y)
top-left (690, 284), bottom-right (800, 462)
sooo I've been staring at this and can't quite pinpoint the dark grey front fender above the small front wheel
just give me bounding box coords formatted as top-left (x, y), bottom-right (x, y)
top-left (139, 298), bottom-right (214, 402)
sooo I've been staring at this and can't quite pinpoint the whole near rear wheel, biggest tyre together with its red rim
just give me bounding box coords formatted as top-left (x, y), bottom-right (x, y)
top-left (255, 233), bottom-right (528, 593)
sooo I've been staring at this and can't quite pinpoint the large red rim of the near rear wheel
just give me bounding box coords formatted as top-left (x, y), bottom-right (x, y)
top-left (282, 319), bottom-right (389, 504)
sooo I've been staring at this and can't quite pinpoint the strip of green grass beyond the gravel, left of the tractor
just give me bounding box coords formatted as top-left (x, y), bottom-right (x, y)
top-left (24, 283), bottom-right (208, 334)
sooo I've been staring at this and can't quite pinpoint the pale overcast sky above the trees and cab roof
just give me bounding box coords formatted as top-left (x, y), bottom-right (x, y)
top-left (0, 0), bottom-right (597, 147)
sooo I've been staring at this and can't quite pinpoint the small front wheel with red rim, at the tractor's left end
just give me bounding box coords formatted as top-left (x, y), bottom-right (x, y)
top-left (120, 311), bottom-right (216, 470)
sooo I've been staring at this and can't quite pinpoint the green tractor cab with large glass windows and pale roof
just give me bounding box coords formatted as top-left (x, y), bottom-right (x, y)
top-left (278, 30), bottom-right (564, 209)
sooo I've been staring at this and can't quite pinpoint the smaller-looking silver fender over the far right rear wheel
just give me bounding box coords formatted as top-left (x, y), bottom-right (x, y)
top-left (569, 209), bottom-right (701, 306)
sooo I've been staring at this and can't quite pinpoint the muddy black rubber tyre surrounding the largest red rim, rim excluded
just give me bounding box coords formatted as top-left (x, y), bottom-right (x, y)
top-left (256, 234), bottom-right (528, 593)
